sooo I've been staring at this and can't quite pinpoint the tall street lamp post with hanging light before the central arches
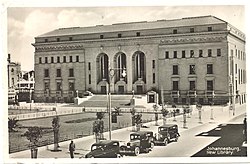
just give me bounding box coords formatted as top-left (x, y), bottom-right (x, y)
top-left (107, 68), bottom-right (127, 140)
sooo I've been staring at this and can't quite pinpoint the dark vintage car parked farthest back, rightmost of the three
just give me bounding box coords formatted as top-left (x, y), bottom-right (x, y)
top-left (154, 124), bottom-right (180, 145)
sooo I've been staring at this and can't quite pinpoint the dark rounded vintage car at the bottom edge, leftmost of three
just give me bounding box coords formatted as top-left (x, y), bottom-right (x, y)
top-left (85, 140), bottom-right (121, 158)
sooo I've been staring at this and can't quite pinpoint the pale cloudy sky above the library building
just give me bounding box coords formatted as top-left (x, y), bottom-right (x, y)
top-left (7, 5), bottom-right (246, 71)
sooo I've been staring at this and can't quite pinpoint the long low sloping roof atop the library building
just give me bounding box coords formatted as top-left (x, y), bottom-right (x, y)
top-left (38, 15), bottom-right (227, 38)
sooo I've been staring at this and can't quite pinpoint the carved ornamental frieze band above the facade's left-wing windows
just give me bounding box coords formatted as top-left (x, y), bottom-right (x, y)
top-left (35, 44), bottom-right (83, 52)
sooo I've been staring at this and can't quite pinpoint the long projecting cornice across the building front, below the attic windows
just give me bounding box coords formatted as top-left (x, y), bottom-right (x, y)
top-left (32, 31), bottom-right (228, 52)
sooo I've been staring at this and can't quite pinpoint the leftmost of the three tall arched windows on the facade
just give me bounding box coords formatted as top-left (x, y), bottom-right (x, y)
top-left (97, 53), bottom-right (109, 81)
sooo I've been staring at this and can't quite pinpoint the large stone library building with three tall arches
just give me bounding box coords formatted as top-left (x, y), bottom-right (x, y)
top-left (32, 16), bottom-right (246, 104)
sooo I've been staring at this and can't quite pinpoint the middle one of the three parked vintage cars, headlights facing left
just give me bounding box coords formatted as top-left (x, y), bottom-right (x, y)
top-left (120, 131), bottom-right (154, 156)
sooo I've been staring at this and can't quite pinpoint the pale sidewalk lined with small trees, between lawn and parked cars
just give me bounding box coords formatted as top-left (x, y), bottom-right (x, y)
top-left (10, 104), bottom-right (246, 158)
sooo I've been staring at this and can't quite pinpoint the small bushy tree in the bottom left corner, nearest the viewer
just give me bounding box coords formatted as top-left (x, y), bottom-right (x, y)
top-left (23, 126), bottom-right (42, 158)
